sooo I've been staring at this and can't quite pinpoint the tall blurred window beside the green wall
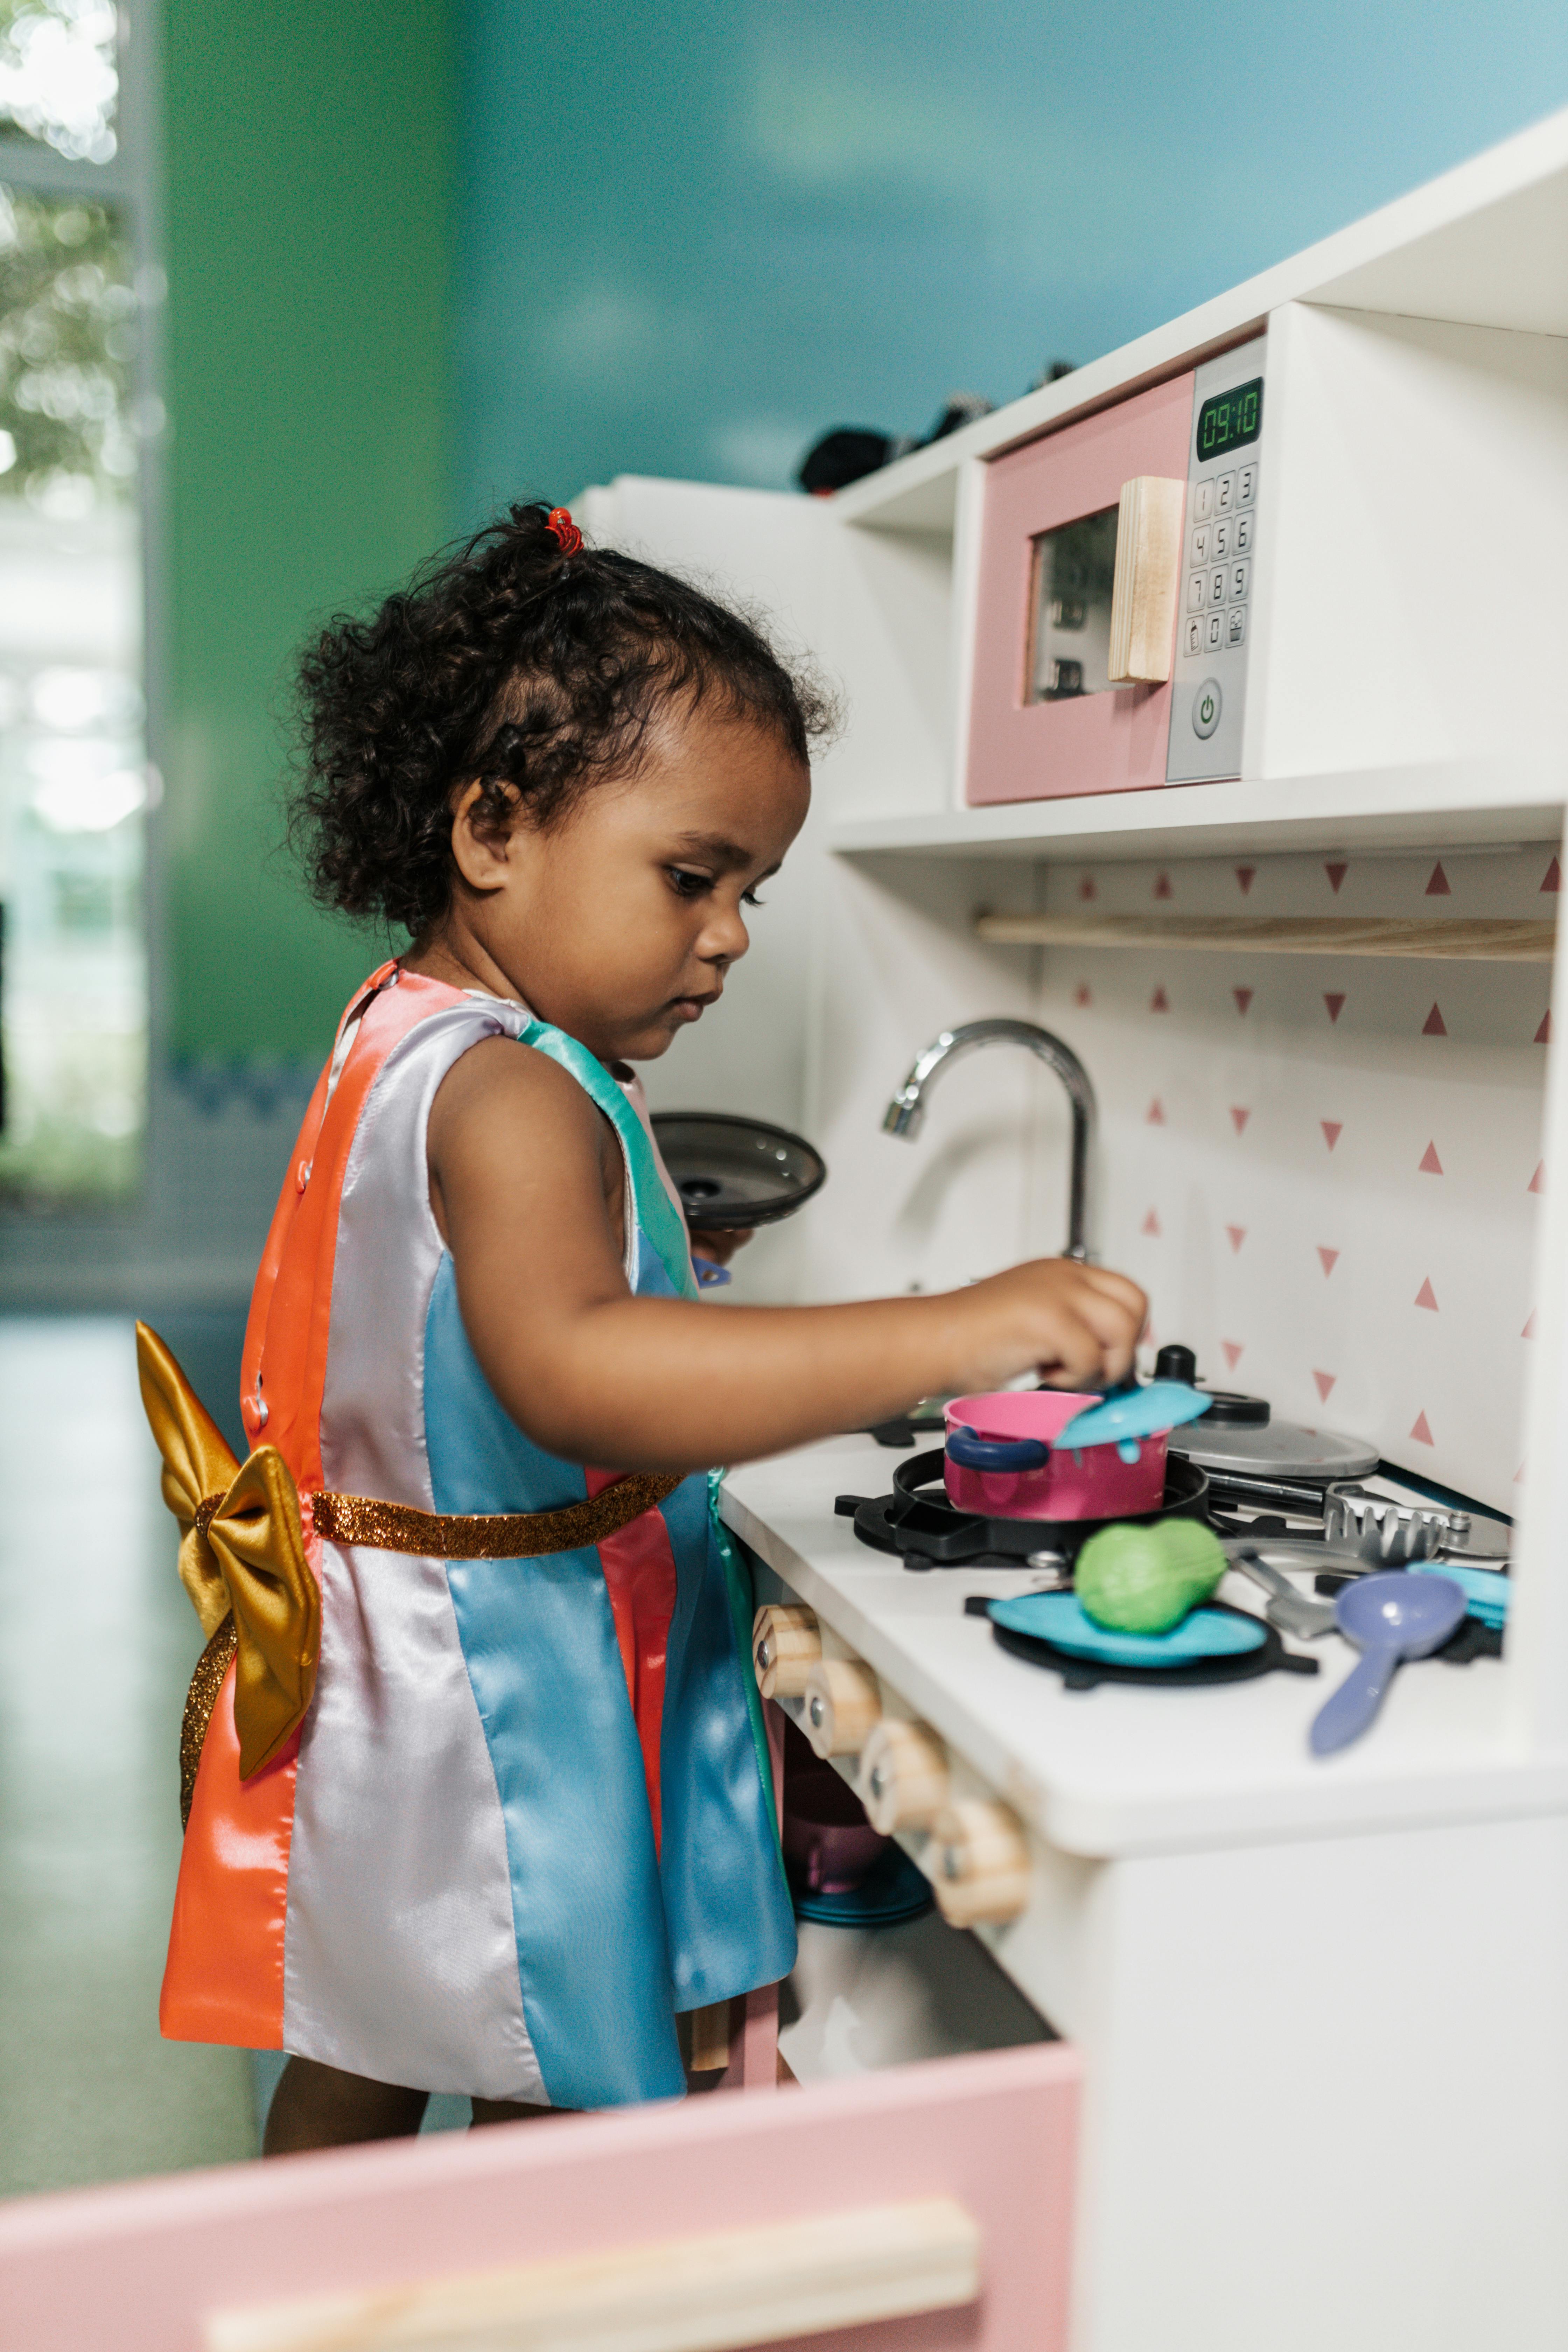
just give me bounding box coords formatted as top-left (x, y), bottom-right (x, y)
top-left (0, 0), bottom-right (145, 1202)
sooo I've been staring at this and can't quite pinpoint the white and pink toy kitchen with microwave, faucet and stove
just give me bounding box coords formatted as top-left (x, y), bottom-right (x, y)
top-left (18, 115), bottom-right (1568, 2352)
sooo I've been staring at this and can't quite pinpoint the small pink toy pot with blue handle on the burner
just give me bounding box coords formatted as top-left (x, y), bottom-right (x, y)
top-left (943, 1388), bottom-right (1171, 1519)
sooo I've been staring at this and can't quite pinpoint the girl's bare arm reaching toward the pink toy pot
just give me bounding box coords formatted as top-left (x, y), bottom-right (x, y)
top-left (430, 1037), bottom-right (1145, 1470)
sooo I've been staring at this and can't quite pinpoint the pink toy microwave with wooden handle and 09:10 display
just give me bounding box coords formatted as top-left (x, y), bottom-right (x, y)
top-left (964, 336), bottom-right (1267, 804)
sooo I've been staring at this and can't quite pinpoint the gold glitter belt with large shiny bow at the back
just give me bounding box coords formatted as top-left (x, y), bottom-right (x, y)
top-left (136, 1324), bottom-right (682, 1820)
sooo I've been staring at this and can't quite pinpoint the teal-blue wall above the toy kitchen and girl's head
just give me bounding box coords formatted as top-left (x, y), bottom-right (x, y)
top-left (458, 0), bottom-right (1568, 517)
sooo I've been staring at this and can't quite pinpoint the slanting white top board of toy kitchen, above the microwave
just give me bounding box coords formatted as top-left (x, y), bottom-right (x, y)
top-left (830, 108), bottom-right (1568, 532)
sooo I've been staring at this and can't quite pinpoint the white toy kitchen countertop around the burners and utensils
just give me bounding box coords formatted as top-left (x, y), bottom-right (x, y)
top-left (722, 1437), bottom-right (1568, 1856)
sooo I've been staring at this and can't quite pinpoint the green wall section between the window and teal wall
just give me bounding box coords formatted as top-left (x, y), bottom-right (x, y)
top-left (162, 0), bottom-right (454, 1061)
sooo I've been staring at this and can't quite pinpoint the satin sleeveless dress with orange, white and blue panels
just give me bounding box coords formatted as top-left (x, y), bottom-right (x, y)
top-left (160, 964), bottom-right (794, 2107)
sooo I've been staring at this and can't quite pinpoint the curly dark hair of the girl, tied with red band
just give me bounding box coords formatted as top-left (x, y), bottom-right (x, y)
top-left (289, 506), bottom-right (832, 938)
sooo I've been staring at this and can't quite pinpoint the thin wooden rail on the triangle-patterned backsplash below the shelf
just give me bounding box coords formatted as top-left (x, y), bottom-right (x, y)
top-left (975, 915), bottom-right (1556, 964)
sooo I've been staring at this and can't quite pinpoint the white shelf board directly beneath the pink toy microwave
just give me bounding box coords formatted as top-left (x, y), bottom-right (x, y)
top-left (827, 757), bottom-right (1568, 861)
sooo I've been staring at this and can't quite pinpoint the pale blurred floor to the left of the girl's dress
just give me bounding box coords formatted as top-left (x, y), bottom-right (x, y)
top-left (0, 1317), bottom-right (256, 2194)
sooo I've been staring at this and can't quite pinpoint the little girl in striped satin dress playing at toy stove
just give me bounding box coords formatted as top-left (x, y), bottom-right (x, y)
top-left (150, 506), bottom-right (1145, 2152)
